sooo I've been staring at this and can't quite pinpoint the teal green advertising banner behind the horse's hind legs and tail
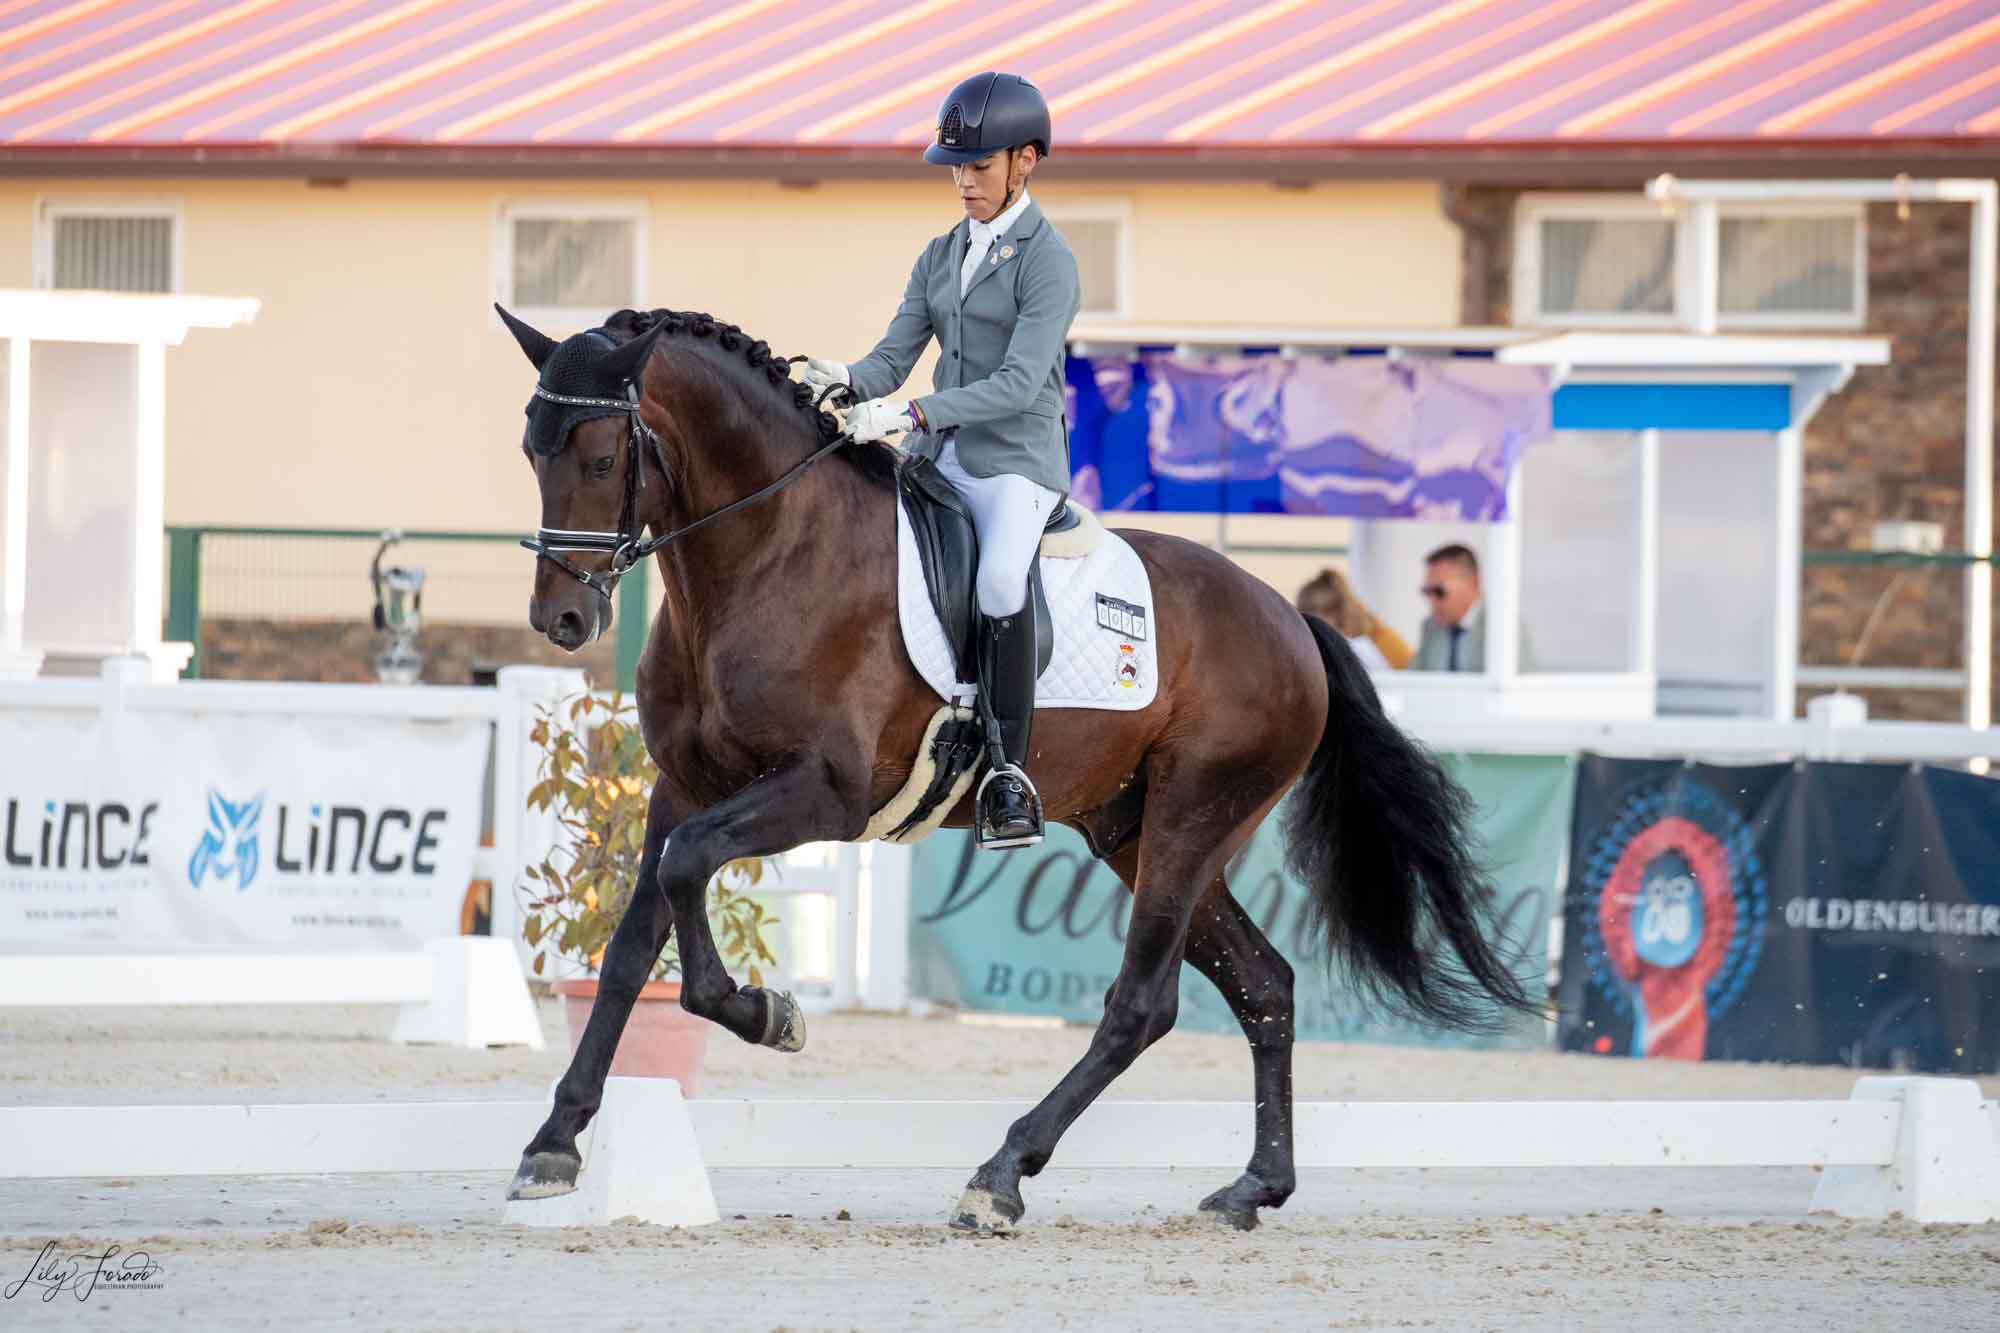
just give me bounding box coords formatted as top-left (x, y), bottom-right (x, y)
top-left (910, 755), bottom-right (1572, 1047)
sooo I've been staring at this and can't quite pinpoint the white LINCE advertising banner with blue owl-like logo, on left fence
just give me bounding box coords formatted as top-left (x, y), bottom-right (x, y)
top-left (0, 709), bottom-right (490, 953)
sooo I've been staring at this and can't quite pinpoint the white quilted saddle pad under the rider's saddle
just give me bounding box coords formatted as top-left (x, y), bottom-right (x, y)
top-left (896, 500), bottom-right (1160, 713)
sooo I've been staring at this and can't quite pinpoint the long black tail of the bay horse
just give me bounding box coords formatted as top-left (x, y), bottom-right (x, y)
top-left (1286, 616), bottom-right (1540, 1031)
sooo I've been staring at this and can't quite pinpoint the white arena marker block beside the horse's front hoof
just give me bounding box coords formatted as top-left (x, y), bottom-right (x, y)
top-left (504, 1079), bottom-right (722, 1227)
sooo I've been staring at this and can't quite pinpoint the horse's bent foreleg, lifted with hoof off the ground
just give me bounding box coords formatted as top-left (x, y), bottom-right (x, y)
top-left (660, 755), bottom-right (868, 1051)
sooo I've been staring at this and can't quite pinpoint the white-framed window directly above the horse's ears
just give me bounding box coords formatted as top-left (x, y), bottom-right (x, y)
top-left (494, 200), bottom-right (646, 326)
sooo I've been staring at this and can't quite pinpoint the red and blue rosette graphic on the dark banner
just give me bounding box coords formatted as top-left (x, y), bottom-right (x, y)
top-left (1584, 775), bottom-right (1766, 1061)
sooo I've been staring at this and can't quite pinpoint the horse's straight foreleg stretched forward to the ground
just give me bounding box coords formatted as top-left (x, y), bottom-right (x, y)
top-left (506, 787), bottom-right (674, 1199)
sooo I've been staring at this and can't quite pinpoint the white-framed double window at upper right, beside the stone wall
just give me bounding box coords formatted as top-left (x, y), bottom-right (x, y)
top-left (1514, 194), bottom-right (1868, 328)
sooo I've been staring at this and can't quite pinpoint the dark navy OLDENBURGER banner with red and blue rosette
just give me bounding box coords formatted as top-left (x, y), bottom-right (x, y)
top-left (1560, 757), bottom-right (2000, 1073)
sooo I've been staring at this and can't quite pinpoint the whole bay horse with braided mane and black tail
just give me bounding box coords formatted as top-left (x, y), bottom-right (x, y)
top-left (500, 310), bottom-right (1534, 1231)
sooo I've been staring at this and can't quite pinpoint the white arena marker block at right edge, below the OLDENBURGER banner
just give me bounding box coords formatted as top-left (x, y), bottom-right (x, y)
top-left (1812, 1077), bottom-right (2000, 1223)
